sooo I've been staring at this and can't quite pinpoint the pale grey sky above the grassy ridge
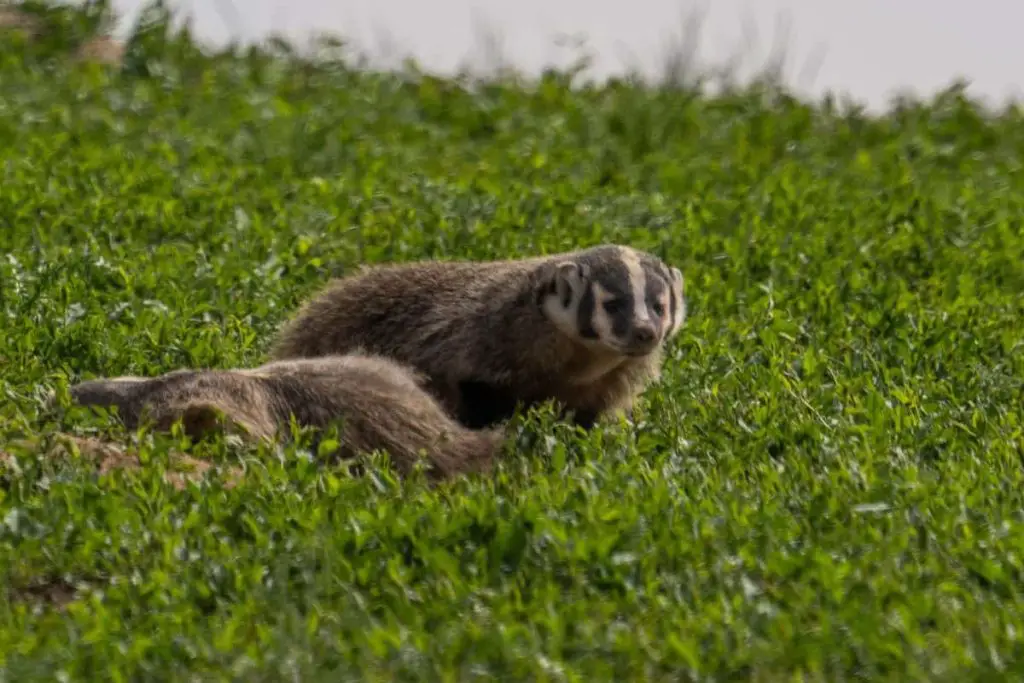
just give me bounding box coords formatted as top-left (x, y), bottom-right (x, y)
top-left (108, 0), bottom-right (1024, 108)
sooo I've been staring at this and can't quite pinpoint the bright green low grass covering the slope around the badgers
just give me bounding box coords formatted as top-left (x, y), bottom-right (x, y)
top-left (0, 2), bottom-right (1024, 683)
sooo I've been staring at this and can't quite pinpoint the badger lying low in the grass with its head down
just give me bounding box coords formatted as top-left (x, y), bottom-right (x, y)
top-left (71, 353), bottom-right (502, 478)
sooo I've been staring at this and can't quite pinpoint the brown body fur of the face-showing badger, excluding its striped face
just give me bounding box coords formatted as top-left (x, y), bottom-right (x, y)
top-left (270, 245), bottom-right (682, 427)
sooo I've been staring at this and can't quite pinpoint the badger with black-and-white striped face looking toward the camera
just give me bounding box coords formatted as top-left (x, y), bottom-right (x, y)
top-left (270, 245), bottom-right (686, 429)
